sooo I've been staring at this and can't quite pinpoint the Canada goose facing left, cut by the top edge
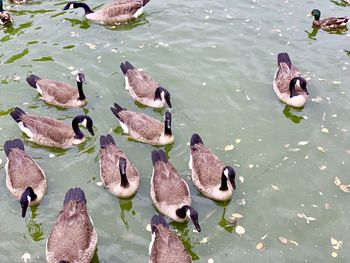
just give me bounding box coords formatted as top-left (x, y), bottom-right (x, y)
top-left (63, 0), bottom-right (150, 25)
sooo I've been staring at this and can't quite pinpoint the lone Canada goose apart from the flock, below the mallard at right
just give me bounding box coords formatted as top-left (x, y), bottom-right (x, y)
top-left (273, 53), bottom-right (309, 107)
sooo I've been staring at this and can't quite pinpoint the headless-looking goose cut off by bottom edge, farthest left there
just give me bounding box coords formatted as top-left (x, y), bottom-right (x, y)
top-left (46, 188), bottom-right (98, 263)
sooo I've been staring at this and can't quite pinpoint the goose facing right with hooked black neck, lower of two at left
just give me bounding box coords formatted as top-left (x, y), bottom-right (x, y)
top-left (10, 107), bottom-right (94, 148)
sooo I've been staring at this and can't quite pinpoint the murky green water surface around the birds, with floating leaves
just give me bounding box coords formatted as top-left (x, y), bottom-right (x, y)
top-left (0, 0), bottom-right (350, 263)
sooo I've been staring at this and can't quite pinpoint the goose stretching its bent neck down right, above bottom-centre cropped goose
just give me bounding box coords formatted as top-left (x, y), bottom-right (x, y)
top-left (151, 150), bottom-right (201, 232)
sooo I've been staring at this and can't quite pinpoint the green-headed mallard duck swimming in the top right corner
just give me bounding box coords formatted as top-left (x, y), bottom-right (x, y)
top-left (310, 9), bottom-right (349, 30)
